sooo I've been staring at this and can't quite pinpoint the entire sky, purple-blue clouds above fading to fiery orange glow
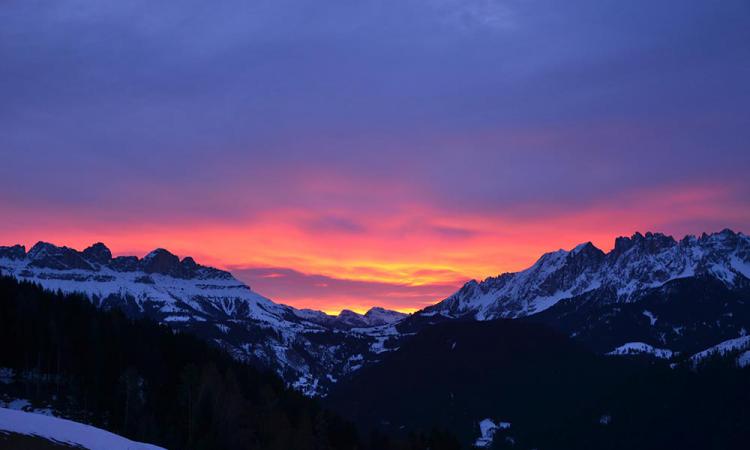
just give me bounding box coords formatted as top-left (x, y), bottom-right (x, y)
top-left (0, 0), bottom-right (750, 312)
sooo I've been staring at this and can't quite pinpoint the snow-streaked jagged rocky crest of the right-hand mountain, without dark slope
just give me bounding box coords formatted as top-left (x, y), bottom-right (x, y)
top-left (424, 230), bottom-right (750, 320)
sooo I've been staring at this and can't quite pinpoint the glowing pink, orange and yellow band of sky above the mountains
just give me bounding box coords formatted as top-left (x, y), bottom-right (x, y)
top-left (1, 181), bottom-right (750, 313)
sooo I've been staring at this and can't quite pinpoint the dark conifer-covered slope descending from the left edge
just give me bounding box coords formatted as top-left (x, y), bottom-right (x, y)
top-left (0, 277), bottom-right (459, 450)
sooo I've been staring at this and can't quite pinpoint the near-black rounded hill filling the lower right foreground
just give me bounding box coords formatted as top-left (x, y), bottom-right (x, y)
top-left (326, 321), bottom-right (750, 449)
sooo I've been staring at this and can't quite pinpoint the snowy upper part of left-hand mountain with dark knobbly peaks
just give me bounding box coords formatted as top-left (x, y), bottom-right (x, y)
top-left (0, 242), bottom-right (289, 321)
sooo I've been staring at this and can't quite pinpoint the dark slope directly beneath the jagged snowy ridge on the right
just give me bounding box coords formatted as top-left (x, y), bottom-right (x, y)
top-left (520, 276), bottom-right (750, 354)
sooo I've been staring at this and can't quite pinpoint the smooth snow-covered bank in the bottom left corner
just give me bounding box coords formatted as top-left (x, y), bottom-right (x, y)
top-left (0, 408), bottom-right (164, 450)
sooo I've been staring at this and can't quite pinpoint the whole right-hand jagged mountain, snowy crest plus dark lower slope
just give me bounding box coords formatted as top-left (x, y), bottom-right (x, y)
top-left (414, 230), bottom-right (750, 360)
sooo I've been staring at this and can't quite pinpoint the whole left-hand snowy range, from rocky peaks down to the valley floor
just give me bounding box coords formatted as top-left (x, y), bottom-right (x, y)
top-left (0, 242), bottom-right (404, 395)
